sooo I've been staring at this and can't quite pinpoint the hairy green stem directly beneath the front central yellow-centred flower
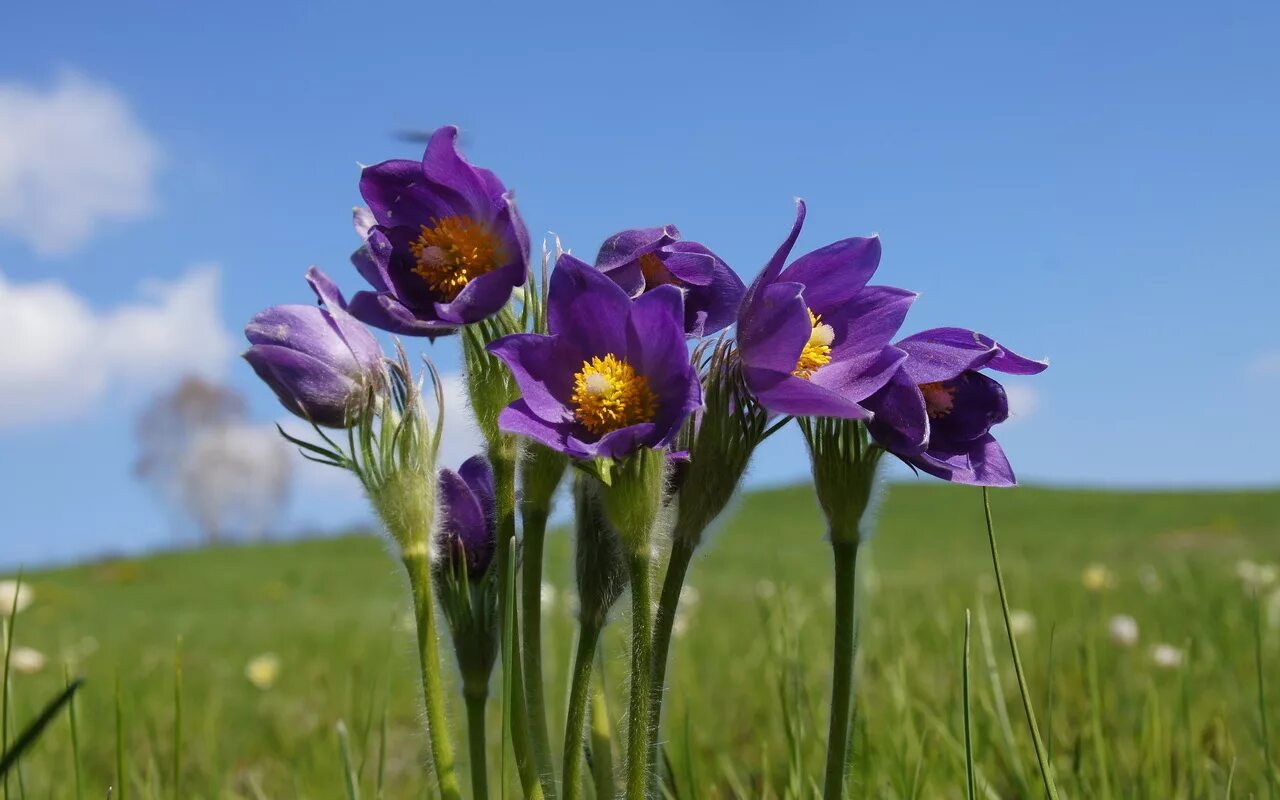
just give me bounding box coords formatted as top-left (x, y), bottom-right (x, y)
top-left (626, 547), bottom-right (653, 800)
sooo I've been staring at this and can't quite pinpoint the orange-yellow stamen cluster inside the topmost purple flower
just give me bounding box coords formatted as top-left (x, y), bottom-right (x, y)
top-left (408, 215), bottom-right (500, 302)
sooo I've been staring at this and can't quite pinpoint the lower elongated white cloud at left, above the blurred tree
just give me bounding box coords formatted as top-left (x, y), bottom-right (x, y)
top-left (0, 265), bottom-right (232, 428)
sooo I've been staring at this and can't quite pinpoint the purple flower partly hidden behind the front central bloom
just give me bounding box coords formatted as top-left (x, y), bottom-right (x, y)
top-left (595, 225), bottom-right (746, 337)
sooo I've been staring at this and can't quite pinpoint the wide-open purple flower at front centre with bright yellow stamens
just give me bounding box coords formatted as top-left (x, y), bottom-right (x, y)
top-left (489, 253), bottom-right (701, 458)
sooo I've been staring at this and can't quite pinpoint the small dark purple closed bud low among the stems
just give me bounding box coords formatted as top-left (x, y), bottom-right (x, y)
top-left (438, 456), bottom-right (498, 580)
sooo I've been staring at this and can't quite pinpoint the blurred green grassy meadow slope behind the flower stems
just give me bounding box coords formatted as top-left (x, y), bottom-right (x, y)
top-left (8, 484), bottom-right (1280, 800)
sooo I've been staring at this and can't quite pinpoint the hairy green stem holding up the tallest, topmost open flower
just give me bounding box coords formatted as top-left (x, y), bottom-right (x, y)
top-left (489, 434), bottom-right (552, 800)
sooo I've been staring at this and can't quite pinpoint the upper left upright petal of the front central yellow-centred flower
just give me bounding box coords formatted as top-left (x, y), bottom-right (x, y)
top-left (547, 253), bottom-right (631, 356)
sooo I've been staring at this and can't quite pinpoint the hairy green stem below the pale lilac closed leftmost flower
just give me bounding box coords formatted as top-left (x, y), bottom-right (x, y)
top-left (401, 547), bottom-right (462, 800)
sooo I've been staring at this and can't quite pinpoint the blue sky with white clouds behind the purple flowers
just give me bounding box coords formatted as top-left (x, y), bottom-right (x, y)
top-left (0, 1), bottom-right (1280, 563)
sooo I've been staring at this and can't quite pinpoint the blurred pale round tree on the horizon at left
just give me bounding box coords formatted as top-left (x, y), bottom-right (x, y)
top-left (134, 376), bottom-right (293, 541)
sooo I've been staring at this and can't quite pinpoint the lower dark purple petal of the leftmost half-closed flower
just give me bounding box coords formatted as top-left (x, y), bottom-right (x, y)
top-left (244, 344), bottom-right (356, 428)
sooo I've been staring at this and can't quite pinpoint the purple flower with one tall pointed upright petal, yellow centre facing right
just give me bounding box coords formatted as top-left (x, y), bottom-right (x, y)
top-left (737, 200), bottom-right (915, 420)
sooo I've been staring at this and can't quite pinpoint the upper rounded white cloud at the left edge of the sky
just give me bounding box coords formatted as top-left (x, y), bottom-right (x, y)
top-left (0, 72), bottom-right (161, 255)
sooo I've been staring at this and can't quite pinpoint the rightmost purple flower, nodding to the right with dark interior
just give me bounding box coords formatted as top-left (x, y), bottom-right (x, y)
top-left (863, 328), bottom-right (1048, 486)
